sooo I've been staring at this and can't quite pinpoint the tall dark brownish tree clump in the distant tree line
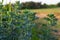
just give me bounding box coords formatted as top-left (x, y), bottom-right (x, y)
top-left (21, 1), bottom-right (42, 9)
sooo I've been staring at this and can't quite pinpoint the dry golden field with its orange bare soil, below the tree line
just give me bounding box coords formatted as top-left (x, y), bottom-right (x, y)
top-left (30, 8), bottom-right (60, 19)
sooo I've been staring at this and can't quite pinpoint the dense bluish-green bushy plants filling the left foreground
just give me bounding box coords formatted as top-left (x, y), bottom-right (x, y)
top-left (0, 4), bottom-right (36, 40)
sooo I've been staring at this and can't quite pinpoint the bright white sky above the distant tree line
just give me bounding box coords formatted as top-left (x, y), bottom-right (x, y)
top-left (20, 0), bottom-right (60, 4)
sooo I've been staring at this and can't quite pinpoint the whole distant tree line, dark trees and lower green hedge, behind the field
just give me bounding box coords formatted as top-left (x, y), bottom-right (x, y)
top-left (21, 1), bottom-right (60, 9)
